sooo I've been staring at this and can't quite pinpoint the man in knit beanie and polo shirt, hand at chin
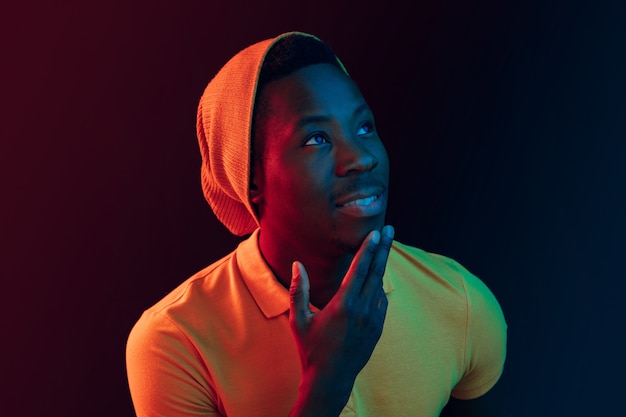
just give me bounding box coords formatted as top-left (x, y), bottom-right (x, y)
top-left (127, 32), bottom-right (507, 417)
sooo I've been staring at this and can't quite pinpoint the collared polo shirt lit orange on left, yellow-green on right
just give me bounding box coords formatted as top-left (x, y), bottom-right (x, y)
top-left (127, 230), bottom-right (506, 417)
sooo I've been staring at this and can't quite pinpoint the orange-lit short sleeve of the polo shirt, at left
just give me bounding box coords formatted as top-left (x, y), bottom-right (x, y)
top-left (126, 311), bottom-right (220, 417)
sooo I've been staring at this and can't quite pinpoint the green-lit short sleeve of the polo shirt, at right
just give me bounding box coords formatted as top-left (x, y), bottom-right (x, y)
top-left (452, 264), bottom-right (507, 400)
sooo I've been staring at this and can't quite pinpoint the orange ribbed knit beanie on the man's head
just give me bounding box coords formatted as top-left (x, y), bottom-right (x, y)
top-left (196, 32), bottom-right (345, 236)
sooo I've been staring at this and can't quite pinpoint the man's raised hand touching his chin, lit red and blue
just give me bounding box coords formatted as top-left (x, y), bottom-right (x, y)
top-left (289, 226), bottom-right (394, 416)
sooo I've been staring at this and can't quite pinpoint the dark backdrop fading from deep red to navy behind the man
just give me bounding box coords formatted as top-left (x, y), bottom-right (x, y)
top-left (0, 0), bottom-right (626, 417)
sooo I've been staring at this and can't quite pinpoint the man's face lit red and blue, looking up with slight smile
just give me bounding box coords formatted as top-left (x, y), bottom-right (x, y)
top-left (251, 64), bottom-right (389, 254)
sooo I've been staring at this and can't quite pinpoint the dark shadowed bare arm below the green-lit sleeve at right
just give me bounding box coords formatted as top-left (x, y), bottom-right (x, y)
top-left (440, 373), bottom-right (511, 417)
